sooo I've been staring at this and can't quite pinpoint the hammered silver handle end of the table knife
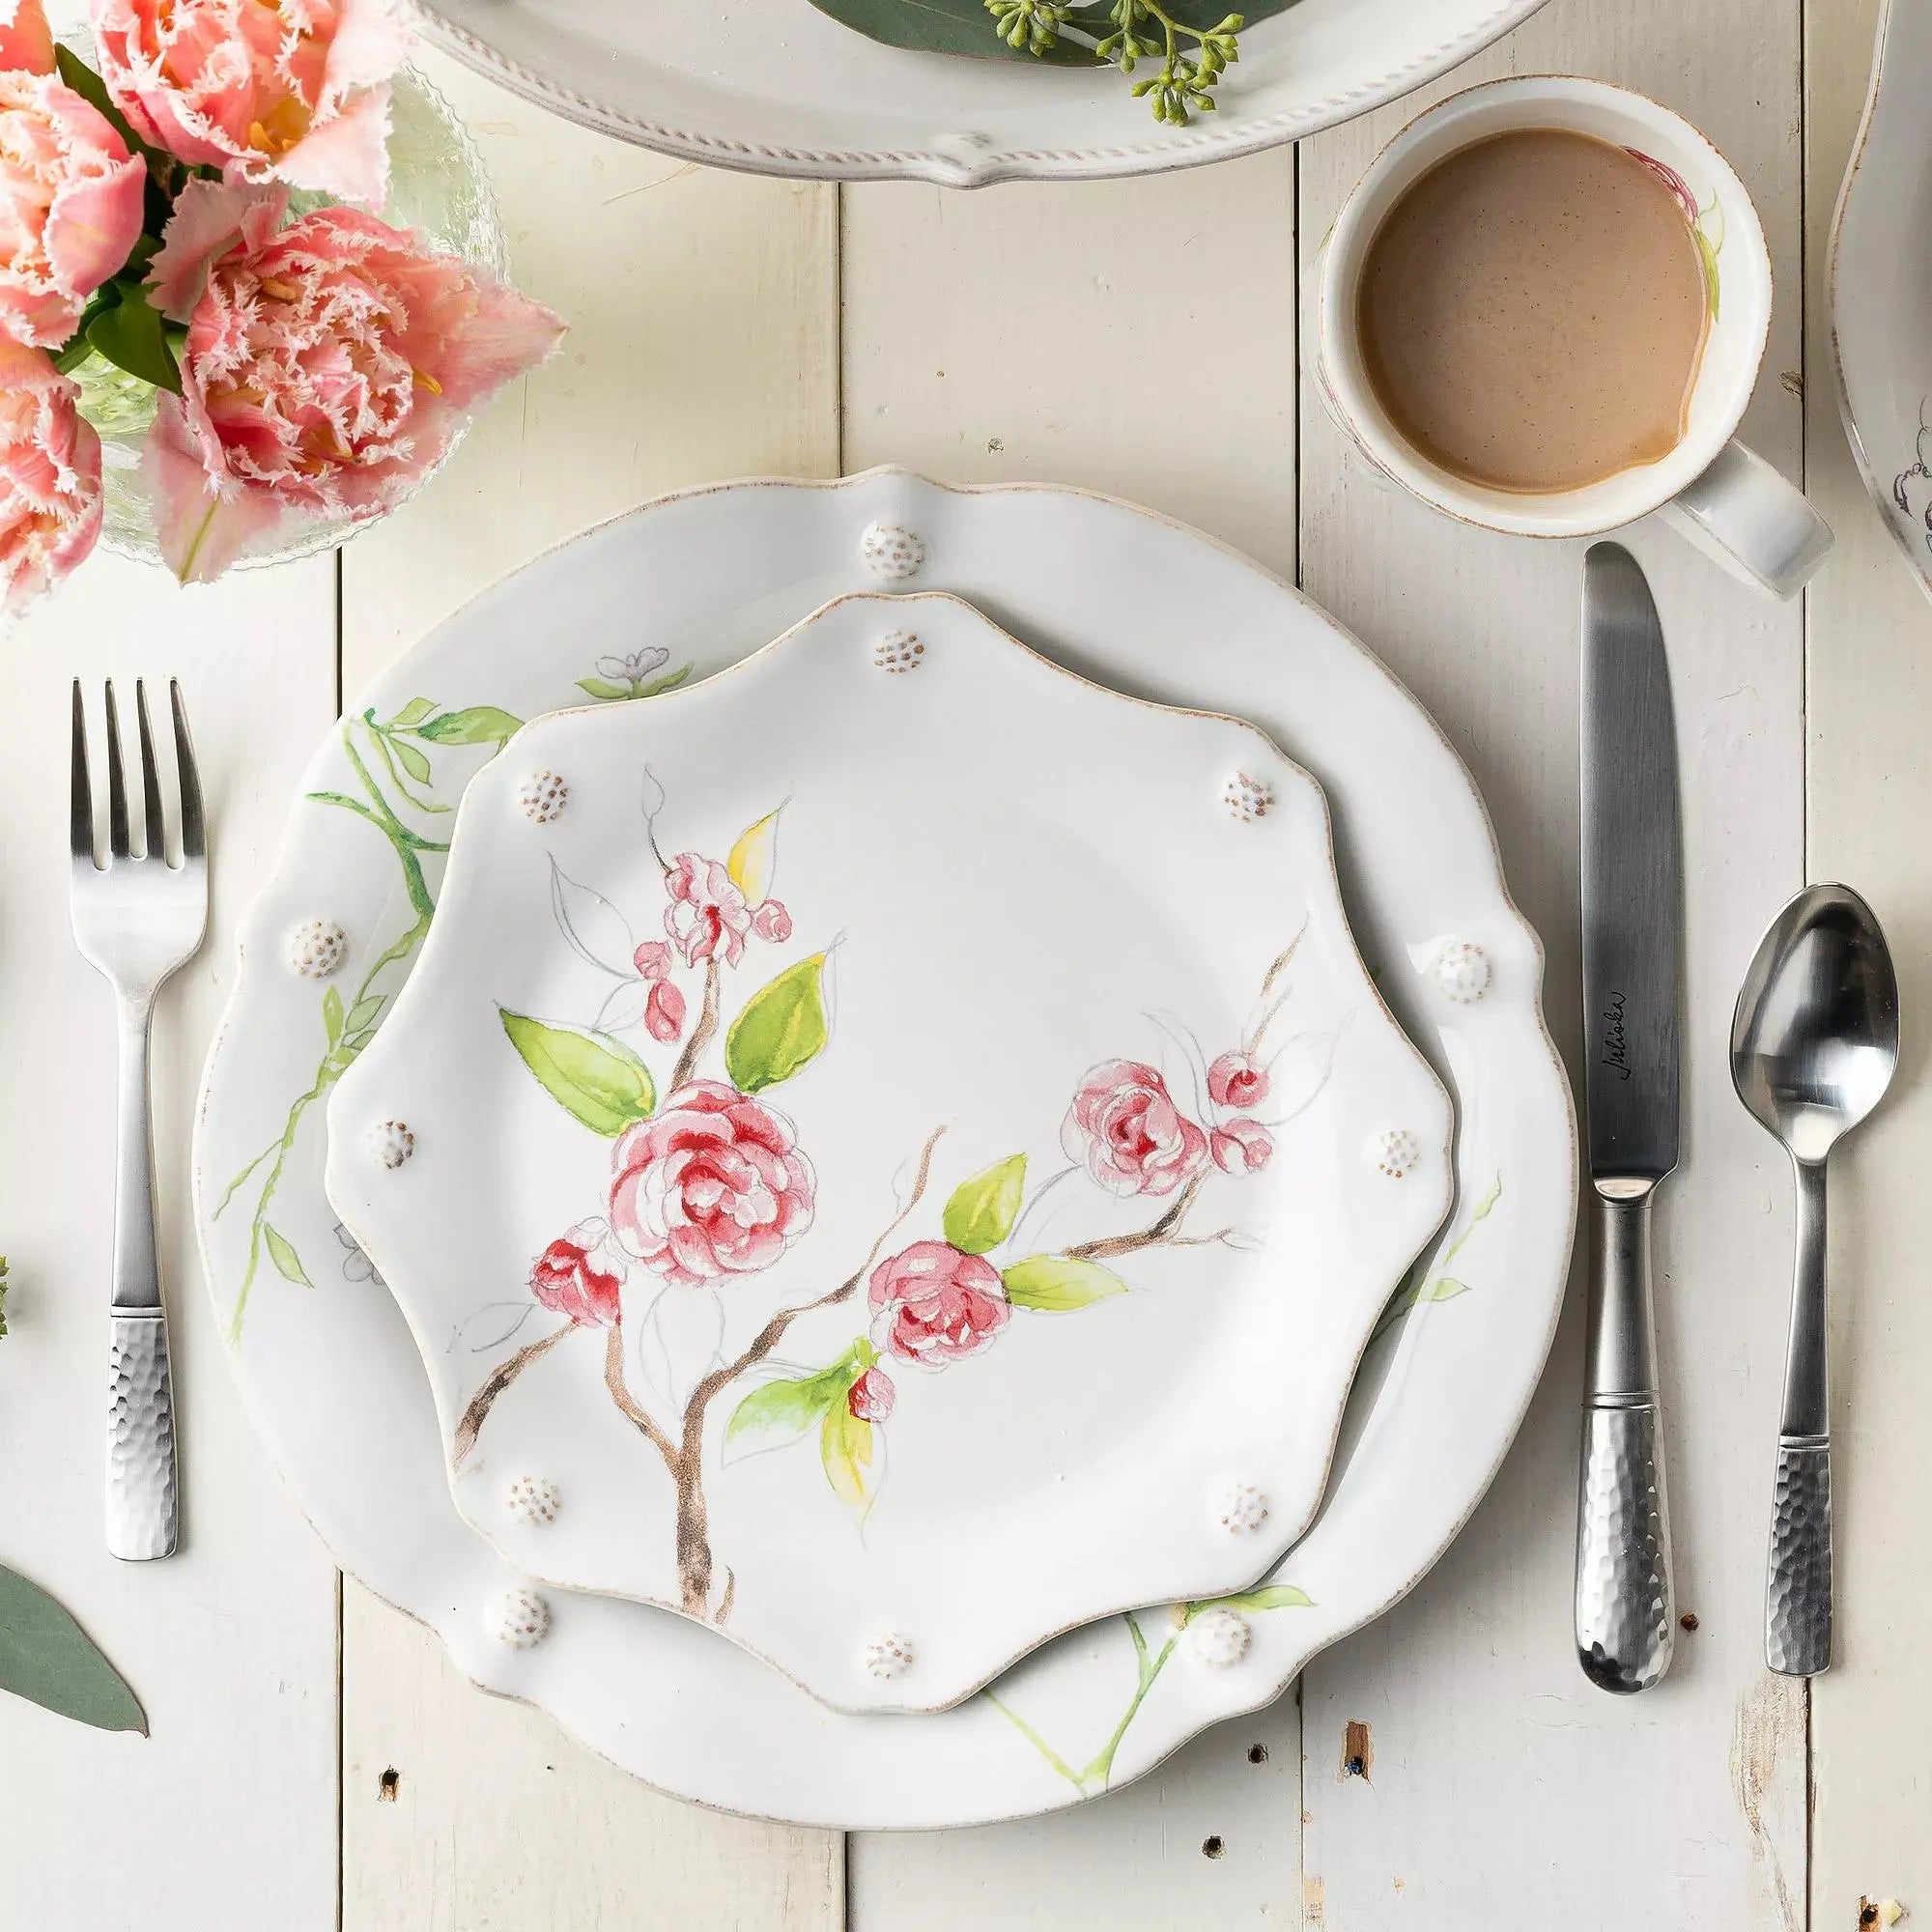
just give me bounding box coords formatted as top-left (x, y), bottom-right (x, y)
top-left (1577, 1403), bottom-right (1675, 1690)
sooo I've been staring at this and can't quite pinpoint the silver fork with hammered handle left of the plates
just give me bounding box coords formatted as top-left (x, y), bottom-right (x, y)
top-left (71, 678), bottom-right (209, 1561)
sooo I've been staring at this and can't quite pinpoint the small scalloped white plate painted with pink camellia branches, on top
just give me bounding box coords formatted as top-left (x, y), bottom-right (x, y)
top-left (327, 595), bottom-right (1451, 1712)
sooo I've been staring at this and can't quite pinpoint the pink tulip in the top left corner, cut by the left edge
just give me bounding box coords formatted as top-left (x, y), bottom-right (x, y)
top-left (0, 0), bottom-right (147, 350)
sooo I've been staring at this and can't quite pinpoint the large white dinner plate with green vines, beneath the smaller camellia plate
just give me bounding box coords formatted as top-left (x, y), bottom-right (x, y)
top-left (195, 469), bottom-right (1577, 1830)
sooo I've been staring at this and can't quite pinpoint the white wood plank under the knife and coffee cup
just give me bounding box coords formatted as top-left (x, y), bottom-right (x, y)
top-left (1300, 0), bottom-right (1804, 1932)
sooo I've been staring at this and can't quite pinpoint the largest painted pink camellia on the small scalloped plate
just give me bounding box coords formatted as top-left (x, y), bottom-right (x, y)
top-left (611, 1080), bottom-right (817, 1287)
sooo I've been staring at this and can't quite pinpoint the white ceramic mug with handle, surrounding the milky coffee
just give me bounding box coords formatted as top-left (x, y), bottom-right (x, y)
top-left (1316, 75), bottom-right (1832, 597)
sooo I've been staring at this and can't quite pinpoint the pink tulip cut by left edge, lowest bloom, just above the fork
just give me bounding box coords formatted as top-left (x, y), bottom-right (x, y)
top-left (0, 338), bottom-right (100, 616)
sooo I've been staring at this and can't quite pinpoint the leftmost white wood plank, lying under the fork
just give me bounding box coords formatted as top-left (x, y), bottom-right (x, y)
top-left (0, 556), bottom-right (336, 1932)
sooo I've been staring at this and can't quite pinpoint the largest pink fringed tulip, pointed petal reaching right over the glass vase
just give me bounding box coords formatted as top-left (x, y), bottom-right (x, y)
top-left (147, 182), bottom-right (564, 583)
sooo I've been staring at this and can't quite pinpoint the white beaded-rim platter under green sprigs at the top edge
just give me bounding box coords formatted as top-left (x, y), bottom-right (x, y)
top-left (415, 0), bottom-right (1542, 187)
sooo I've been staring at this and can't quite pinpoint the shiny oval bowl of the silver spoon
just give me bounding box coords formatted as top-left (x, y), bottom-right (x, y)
top-left (1731, 885), bottom-right (1899, 1161)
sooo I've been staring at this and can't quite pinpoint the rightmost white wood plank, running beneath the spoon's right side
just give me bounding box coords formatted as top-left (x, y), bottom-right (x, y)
top-left (1804, 0), bottom-right (1932, 1932)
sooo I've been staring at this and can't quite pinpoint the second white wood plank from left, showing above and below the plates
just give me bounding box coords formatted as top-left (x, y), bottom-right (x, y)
top-left (330, 45), bottom-right (842, 1932)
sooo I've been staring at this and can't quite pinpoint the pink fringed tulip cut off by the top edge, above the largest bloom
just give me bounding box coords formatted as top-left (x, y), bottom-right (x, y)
top-left (93, 0), bottom-right (410, 205)
